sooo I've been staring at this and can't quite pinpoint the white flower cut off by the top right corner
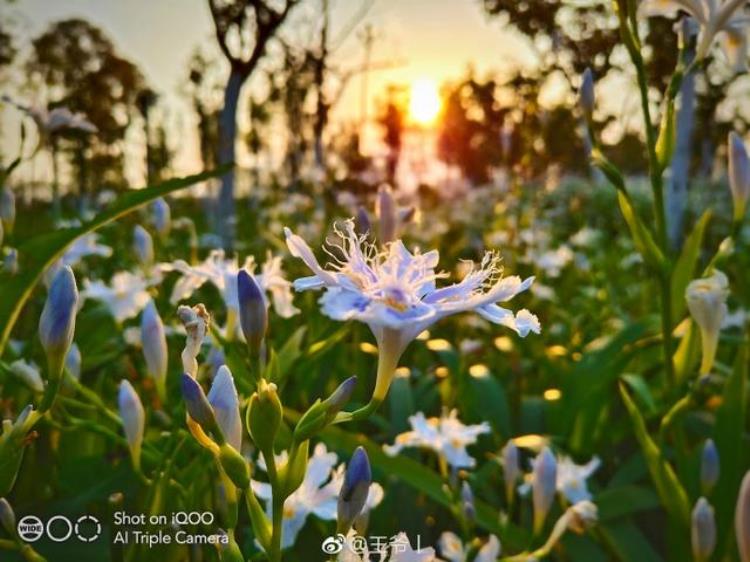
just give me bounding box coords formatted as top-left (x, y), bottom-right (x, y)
top-left (639, 0), bottom-right (748, 71)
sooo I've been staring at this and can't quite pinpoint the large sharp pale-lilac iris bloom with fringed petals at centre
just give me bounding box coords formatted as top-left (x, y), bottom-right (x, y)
top-left (284, 219), bottom-right (541, 405)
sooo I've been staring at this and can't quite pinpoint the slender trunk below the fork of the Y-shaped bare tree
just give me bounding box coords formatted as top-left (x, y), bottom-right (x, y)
top-left (217, 68), bottom-right (247, 250)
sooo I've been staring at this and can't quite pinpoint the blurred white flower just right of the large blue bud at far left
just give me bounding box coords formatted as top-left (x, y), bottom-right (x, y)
top-left (81, 271), bottom-right (151, 322)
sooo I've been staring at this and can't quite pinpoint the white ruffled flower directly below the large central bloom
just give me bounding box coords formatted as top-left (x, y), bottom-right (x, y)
top-left (383, 410), bottom-right (490, 469)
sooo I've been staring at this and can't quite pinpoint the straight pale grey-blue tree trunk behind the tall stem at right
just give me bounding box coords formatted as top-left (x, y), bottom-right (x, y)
top-left (667, 66), bottom-right (695, 248)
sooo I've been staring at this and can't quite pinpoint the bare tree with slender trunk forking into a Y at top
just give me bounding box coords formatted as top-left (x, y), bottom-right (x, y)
top-left (208, 0), bottom-right (300, 248)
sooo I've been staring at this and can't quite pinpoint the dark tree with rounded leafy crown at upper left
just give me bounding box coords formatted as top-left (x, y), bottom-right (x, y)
top-left (27, 19), bottom-right (145, 198)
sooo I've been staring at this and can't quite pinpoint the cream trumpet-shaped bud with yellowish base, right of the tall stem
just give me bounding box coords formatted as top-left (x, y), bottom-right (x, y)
top-left (685, 270), bottom-right (729, 375)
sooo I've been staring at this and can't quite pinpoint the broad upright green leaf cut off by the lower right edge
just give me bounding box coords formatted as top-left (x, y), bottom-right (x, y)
top-left (711, 343), bottom-right (748, 560)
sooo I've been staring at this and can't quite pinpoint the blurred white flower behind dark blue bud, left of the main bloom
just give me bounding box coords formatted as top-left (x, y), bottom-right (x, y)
top-left (166, 250), bottom-right (299, 318)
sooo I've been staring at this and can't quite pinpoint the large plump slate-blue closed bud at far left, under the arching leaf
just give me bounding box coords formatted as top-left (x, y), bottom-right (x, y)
top-left (39, 266), bottom-right (78, 380)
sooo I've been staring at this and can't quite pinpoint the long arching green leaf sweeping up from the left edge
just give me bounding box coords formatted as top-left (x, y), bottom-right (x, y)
top-left (0, 166), bottom-right (229, 355)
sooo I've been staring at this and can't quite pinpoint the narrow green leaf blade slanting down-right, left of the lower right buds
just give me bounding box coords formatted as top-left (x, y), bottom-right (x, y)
top-left (620, 385), bottom-right (690, 532)
